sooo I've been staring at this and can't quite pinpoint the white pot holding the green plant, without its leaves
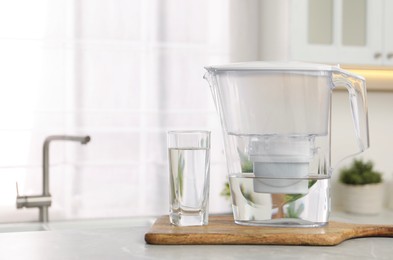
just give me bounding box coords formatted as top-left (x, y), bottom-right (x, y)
top-left (342, 183), bottom-right (384, 215)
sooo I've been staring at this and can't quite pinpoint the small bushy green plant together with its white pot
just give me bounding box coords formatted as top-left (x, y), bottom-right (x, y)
top-left (339, 159), bottom-right (384, 214)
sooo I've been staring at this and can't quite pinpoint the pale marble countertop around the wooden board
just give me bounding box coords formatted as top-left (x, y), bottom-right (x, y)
top-left (0, 211), bottom-right (393, 260)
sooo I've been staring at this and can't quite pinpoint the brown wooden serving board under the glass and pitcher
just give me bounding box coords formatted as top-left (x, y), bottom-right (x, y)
top-left (145, 215), bottom-right (393, 246)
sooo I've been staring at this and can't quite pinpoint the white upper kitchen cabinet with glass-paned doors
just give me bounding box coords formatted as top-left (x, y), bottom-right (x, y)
top-left (289, 0), bottom-right (393, 66)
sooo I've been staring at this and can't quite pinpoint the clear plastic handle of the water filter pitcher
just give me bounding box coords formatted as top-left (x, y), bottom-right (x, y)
top-left (332, 68), bottom-right (370, 164)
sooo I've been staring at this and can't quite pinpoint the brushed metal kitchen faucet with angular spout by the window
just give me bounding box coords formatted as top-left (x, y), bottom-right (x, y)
top-left (16, 135), bottom-right (90, 222)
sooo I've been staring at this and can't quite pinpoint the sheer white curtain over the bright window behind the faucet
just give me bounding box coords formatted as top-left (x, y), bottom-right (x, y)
top-left (0, 0), bottom-right (259, 222)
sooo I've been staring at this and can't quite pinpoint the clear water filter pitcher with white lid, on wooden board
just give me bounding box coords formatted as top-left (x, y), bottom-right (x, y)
top-left (205, 62), bottom-right (369, 227)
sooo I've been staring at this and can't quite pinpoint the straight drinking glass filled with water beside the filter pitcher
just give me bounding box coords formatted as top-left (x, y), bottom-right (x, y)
top-left (168, 131), bottom-right (210, 226)
